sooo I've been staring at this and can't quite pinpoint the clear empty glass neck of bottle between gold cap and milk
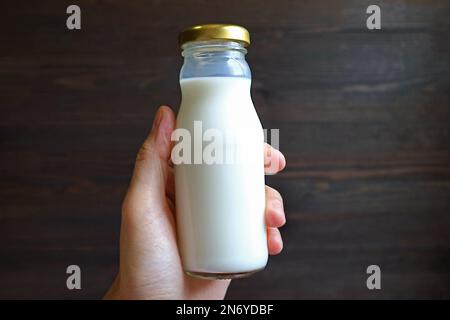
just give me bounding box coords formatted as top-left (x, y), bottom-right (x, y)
top-left (180, 40), bottom-right (251, 80)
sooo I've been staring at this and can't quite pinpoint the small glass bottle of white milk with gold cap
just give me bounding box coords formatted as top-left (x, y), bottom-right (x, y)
top-left (172, 24), bottom-right (268, 279)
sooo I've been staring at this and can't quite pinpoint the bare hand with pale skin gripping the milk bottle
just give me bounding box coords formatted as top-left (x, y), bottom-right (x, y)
top-left (105, 106), bottom-right (286, 299)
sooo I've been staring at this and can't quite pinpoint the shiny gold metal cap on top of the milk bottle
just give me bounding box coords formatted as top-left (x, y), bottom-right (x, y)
top-left (179, 24), bottom-right (250, 47)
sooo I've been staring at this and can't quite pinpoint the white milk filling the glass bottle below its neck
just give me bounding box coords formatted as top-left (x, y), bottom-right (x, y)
top-left (175, 77), bottom-right (268, 278)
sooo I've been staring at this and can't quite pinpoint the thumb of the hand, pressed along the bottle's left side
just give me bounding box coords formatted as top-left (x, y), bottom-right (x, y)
top-left (127, 106), bottom-right (175, 210)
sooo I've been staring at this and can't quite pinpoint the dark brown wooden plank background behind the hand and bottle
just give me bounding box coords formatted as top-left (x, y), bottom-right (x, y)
top-left (0, 0), bottom-right (450, 299)
